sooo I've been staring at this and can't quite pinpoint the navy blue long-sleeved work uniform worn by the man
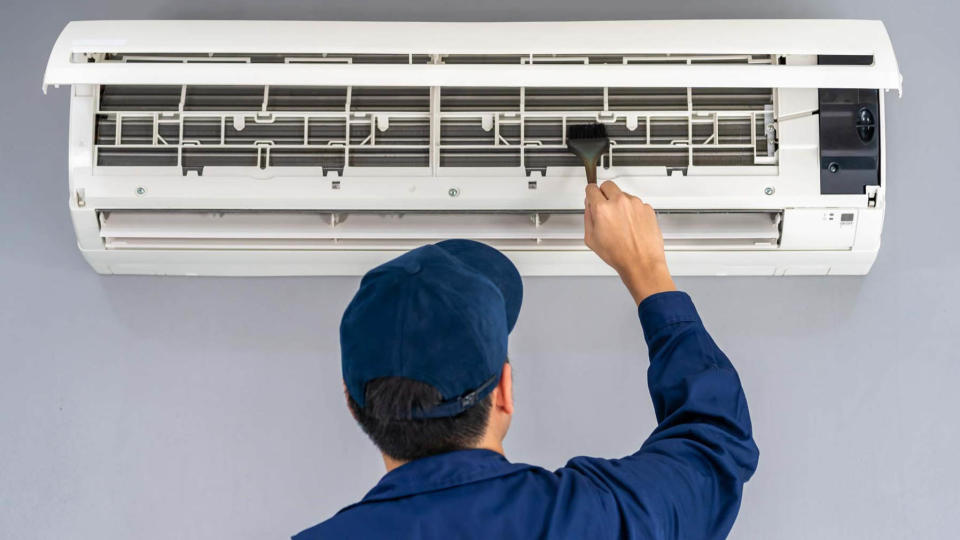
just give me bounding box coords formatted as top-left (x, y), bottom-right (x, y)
top-left (294, 292), bottom-right (759, 540)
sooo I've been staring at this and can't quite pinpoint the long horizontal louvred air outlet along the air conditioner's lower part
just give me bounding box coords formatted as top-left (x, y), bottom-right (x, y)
top-left (100, 210), bottom-right (781, 250)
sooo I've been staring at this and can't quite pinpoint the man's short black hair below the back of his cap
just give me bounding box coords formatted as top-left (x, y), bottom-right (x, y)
top-left (347, 377), bottom-right (493, 461)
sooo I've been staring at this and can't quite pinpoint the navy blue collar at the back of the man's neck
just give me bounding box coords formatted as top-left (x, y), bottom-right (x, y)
top-left (341, 449), bottom-right (533, 512)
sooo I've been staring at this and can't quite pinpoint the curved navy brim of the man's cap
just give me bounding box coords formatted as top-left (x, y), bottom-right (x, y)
top-left (435, 239), bottom-right (523, 332)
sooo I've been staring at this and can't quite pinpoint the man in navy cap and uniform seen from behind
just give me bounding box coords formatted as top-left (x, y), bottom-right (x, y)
top-left (295, 182), bottom-right (758, 540)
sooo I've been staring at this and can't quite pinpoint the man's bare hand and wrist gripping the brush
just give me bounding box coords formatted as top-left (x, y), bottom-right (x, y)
top-left (583, 180), bottom-right (677, 305)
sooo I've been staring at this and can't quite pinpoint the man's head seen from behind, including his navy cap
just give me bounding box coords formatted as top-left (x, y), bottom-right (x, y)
top-left (340, 240), bottom-right (523, 461)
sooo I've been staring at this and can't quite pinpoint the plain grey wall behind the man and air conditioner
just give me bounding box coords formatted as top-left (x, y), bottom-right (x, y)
top-left (0, 0), bottom-right (960, 540)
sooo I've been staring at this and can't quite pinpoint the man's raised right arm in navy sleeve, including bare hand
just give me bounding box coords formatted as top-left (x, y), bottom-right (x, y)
top-left (568, 182), bottom-right (759, 539)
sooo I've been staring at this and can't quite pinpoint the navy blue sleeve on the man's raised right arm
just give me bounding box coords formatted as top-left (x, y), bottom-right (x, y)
top-left (558, 291), bottom-right (759, 539)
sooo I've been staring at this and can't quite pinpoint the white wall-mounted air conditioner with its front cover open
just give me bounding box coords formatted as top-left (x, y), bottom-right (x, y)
top-left (43, 20), bottom-right (901, 275)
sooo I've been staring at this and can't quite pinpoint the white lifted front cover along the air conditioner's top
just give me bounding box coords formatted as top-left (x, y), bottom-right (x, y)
top-left (43, 19), bottom-right (900, 89)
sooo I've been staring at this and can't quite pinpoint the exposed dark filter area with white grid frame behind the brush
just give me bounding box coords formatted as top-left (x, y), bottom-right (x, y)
top-left (95, 83), bottom-right (777, 176)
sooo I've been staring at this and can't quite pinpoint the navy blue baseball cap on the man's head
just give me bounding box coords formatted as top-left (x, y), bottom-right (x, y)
top-left (340, 240), bottom-right (523, 418)
